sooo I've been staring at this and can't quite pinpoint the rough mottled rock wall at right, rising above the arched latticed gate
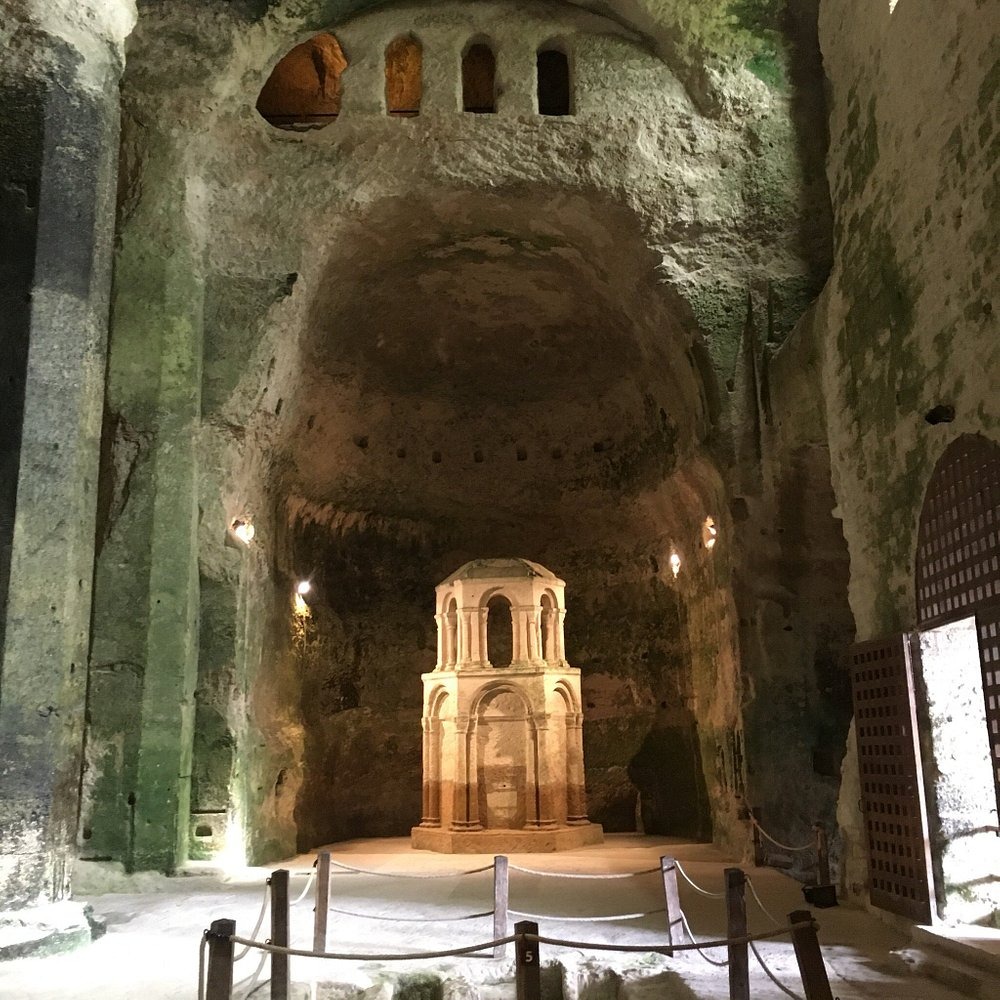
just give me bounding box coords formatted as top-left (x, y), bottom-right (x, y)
top-left (818, 0), bottom-right (1000, 904)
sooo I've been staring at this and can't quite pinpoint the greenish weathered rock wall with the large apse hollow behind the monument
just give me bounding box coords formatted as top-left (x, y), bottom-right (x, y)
top-left (72, 0), bottom-right (844, 868)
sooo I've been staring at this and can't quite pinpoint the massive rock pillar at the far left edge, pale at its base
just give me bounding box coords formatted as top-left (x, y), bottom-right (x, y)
top-left (0, 0), bottom-right (135, 950)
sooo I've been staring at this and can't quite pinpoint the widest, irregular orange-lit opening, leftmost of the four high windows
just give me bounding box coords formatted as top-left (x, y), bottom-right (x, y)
top-left (257, 33), bottom-right (347, 130)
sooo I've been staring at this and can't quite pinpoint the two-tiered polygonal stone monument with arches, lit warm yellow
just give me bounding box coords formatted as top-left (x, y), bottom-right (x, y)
top-left (412, 559), bottom-right (604, 854)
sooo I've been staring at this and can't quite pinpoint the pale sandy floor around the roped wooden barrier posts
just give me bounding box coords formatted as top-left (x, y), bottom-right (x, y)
top-left (0, 835), bottom-right (984, 1000)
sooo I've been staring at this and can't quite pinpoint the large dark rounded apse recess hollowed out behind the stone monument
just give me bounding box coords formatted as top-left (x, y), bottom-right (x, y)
top-left (213, 189), bottom-right (739, 855)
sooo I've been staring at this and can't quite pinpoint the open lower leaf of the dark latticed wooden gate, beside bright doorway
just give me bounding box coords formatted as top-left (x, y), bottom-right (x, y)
top-left (849, 635), bottom-right (934, 923)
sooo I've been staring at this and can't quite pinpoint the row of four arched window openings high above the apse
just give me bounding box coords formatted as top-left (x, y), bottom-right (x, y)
top-left (257, 34), bottom-right (572, 128)
